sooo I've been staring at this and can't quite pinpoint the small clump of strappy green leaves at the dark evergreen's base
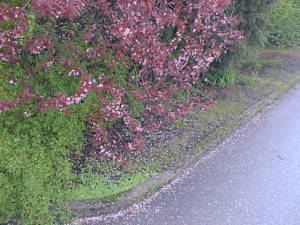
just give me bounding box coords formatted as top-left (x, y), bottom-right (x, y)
top-left (207, 69), bottom-right (236, 87)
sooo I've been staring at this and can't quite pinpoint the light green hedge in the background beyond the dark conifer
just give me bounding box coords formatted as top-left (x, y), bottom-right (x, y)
top-left (268, 0), bottom-right (300, 46)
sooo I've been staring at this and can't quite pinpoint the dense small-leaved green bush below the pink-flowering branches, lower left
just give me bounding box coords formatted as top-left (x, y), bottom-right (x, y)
top-left (0, 108), bottom-right (84, 225)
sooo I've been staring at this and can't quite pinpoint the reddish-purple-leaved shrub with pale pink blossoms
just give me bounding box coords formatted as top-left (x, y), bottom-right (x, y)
top-left (0, 0), bottom-right (242, 162)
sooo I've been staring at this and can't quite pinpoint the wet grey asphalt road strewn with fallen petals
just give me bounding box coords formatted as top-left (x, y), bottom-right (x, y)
top-left (85, 86), bottom-right (300, 225)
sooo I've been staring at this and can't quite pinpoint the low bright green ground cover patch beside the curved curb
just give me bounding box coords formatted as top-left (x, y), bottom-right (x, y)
top-left (69, 159), bottom-right (155, 200)
